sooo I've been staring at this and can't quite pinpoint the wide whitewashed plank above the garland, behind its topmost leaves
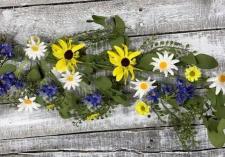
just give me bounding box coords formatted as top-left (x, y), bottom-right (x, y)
top-left (0, 0), bottom-right (225, 43)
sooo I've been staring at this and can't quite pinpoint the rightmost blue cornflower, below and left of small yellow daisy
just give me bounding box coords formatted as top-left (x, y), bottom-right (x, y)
top-left (176, 78), bottom-right (195, 104)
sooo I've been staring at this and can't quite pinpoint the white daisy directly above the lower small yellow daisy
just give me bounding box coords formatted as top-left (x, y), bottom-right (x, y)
top-left (131, 77), bottom-right (156, 99)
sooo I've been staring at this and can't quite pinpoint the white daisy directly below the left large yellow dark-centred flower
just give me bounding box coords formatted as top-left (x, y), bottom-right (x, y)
top-left (59, 71), bottom-right (81, 90)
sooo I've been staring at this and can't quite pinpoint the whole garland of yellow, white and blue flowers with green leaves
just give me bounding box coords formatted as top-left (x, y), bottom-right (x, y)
top-left (0, 15), bottom-right (225, 148)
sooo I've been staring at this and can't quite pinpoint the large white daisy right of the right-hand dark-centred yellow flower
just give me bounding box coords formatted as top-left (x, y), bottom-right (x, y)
top-left (151, 51), bottom-right (179, 77)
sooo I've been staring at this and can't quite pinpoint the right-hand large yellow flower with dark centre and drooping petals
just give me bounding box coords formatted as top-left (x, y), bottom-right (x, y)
top-left (107, 45), bottom-right (141, 82)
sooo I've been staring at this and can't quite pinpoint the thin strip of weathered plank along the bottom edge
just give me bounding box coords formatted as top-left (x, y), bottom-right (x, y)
top-left (3, 149), bottom-right (225, 157)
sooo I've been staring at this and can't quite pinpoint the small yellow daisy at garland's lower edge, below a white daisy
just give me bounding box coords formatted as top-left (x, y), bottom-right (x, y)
top-left (135, 100), bottom-right (151, 116)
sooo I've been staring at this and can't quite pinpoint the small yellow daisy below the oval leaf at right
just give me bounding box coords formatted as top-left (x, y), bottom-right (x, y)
top-left (185, 66), bottom-right (202, 82)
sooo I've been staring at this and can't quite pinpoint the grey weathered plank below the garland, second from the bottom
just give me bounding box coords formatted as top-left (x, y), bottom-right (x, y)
top-left (0, 126), bottom-right (218, 154)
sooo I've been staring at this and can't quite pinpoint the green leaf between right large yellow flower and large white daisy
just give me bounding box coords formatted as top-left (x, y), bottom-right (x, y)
top-left (137, 53), bottom-right (157, 71)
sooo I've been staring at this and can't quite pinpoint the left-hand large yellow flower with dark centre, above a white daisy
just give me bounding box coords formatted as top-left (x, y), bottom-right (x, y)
top-left (51, 39), bottom-right (85, 72)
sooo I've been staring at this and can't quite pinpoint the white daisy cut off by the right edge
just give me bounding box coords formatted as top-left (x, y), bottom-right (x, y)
top-left (207, 72), bottom-right (225, 95)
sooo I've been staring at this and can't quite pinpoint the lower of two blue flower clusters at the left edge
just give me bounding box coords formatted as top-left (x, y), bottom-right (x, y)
top-left (0, 73), bottom-right (24, 96)
